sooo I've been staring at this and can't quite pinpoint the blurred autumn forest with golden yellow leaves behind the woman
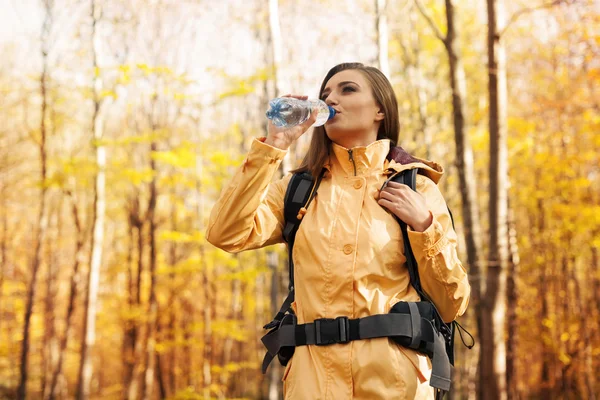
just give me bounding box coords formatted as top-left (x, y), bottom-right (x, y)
top-left (0, 0), bottom-right (600, 400)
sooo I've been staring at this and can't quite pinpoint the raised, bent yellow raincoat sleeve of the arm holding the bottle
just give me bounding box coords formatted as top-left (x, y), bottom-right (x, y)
top-left (206, 138), bottom-right (291, 253)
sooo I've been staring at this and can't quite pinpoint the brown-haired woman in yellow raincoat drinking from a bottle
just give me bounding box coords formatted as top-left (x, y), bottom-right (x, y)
top-left (207, 63), bottom-right (470, 400)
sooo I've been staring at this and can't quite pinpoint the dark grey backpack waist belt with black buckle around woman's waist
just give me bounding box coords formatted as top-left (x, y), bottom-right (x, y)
top-left (261, 302), bottom-right (452, 391)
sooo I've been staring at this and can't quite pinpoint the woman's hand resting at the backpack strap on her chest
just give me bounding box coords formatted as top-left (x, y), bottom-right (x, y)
top-left (378, 181), bottom-right (433, 232)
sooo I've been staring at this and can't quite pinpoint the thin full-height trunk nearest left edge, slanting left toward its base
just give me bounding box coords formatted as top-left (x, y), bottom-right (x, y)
top-left (17, 0), bottom-right (53, 400)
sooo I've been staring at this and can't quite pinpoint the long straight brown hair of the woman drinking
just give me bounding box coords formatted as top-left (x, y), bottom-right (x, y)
top-left (292, 63), bottom-right (400, 178)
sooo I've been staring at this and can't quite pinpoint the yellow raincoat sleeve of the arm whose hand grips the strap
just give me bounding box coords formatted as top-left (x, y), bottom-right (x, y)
top-left (408, 175), bottom-right (471, 322)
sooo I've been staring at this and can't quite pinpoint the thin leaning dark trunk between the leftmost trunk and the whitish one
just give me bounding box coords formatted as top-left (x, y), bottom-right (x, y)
top-left (48, 198), bottom-right (85, 400)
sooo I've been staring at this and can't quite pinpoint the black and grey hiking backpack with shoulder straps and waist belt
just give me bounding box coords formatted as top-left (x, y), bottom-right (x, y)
top-left (262, 165), bottom-right (474, 399)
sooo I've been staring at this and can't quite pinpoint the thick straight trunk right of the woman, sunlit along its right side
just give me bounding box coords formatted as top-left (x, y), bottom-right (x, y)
top-left (479, 0), bottom-right (508, 400)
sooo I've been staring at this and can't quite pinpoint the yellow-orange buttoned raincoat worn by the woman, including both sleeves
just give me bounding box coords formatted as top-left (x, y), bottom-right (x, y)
top-left (207, 140), bottom-right (470, 400)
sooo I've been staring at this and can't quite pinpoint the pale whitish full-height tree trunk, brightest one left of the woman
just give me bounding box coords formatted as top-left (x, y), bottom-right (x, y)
top-left (77, 0), bottom-right (106, 400)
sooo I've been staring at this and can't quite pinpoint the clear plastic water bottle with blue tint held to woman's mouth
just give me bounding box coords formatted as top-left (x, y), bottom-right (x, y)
top-left (267, 97), bottom-right (335, 128)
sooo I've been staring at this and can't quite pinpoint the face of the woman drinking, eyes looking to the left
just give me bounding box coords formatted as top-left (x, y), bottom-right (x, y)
top-left (321, 69), bottom-right (384, 148)
